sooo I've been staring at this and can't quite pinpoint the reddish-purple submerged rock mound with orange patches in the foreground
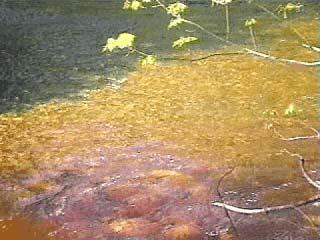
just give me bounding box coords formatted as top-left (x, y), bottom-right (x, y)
top-left (4, 142), bottom-right (230, 240)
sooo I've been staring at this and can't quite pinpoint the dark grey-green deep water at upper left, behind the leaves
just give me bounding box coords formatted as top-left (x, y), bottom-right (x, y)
top-left (0, 0), bottom-right (319, 113)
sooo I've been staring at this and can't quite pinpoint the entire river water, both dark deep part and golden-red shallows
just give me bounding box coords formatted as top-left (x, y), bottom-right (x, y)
top-left (0, 0), bottom-right (320, 240)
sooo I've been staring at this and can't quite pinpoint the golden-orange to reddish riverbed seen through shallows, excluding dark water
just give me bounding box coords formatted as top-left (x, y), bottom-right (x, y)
top-left (0, 0), bottom-right (320, 240)
